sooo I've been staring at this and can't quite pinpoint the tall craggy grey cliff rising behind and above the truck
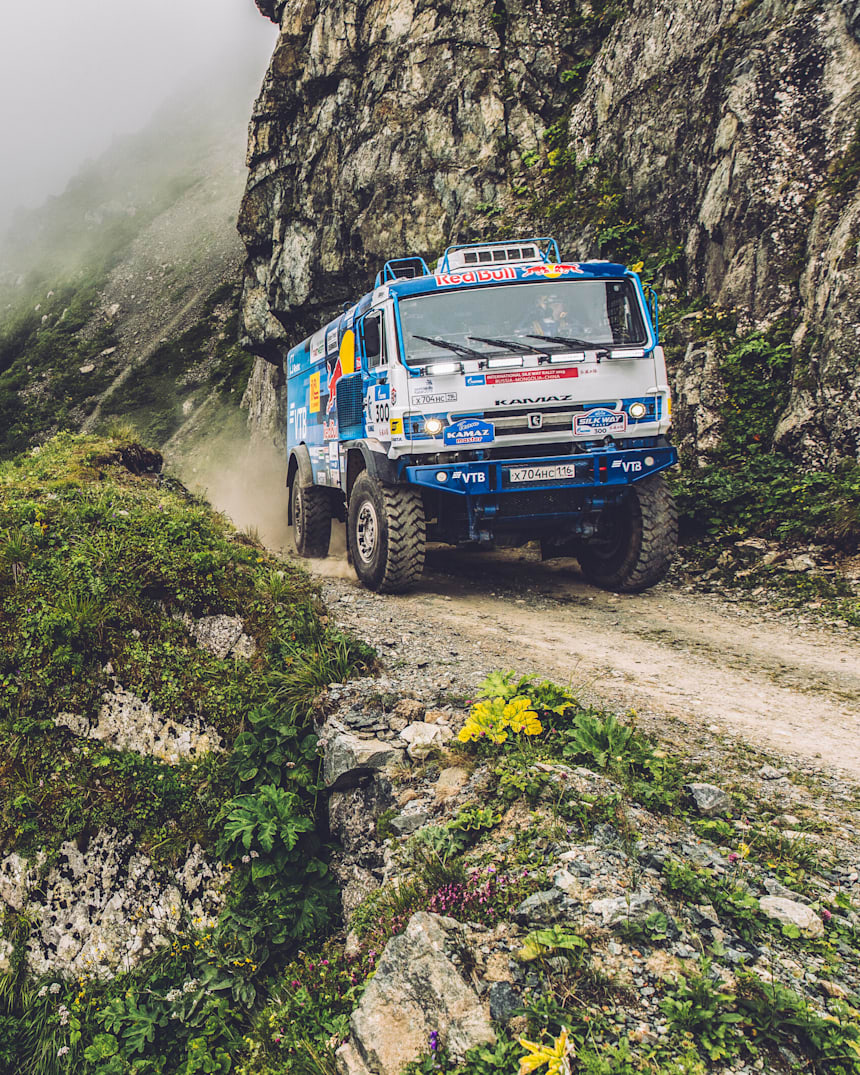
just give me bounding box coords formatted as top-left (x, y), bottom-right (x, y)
top-left (240, 0), bottom-right (860, 462)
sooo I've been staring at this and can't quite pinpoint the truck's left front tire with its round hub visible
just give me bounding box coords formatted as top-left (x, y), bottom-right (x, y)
top-left (346, 471), bottom-right (427, 593)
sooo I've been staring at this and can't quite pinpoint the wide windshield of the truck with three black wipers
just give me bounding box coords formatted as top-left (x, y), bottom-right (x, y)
top-left (400, 280), bottom-right (645, 364)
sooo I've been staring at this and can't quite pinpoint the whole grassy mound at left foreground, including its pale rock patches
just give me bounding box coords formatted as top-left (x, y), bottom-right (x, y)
top-left (0, 434), bottom-right (369, 1073)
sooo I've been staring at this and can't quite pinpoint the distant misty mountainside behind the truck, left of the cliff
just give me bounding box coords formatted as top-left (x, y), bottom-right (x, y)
top-left (0, 65), bottom-right (260, 466)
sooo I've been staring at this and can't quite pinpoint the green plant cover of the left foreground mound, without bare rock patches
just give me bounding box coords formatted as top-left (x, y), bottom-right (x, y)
top-left (0, 434), bottom-right (367, 1073)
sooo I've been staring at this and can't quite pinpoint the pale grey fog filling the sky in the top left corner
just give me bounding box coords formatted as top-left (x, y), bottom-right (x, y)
top-left (0, 0), bottom-right (277, 235)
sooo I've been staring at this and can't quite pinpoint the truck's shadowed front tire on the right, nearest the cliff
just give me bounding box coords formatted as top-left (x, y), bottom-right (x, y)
top-left (576, 474), bottom-right (678, 593)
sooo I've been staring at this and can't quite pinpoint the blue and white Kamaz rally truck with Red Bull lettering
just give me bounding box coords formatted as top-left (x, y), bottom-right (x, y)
top-left (286, 238), bottom-right (677, 592)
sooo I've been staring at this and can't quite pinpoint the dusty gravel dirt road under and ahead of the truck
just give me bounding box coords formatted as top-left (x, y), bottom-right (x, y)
top-left (310, 528), bottom-right (860, 779)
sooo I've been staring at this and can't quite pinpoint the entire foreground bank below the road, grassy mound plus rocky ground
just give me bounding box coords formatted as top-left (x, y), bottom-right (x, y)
top-left (0, 434), bottom-right (860, 1075)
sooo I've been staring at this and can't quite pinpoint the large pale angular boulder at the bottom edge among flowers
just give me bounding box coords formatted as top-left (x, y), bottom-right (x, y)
top-left (338, 912), bottom-right (496, 1075)
